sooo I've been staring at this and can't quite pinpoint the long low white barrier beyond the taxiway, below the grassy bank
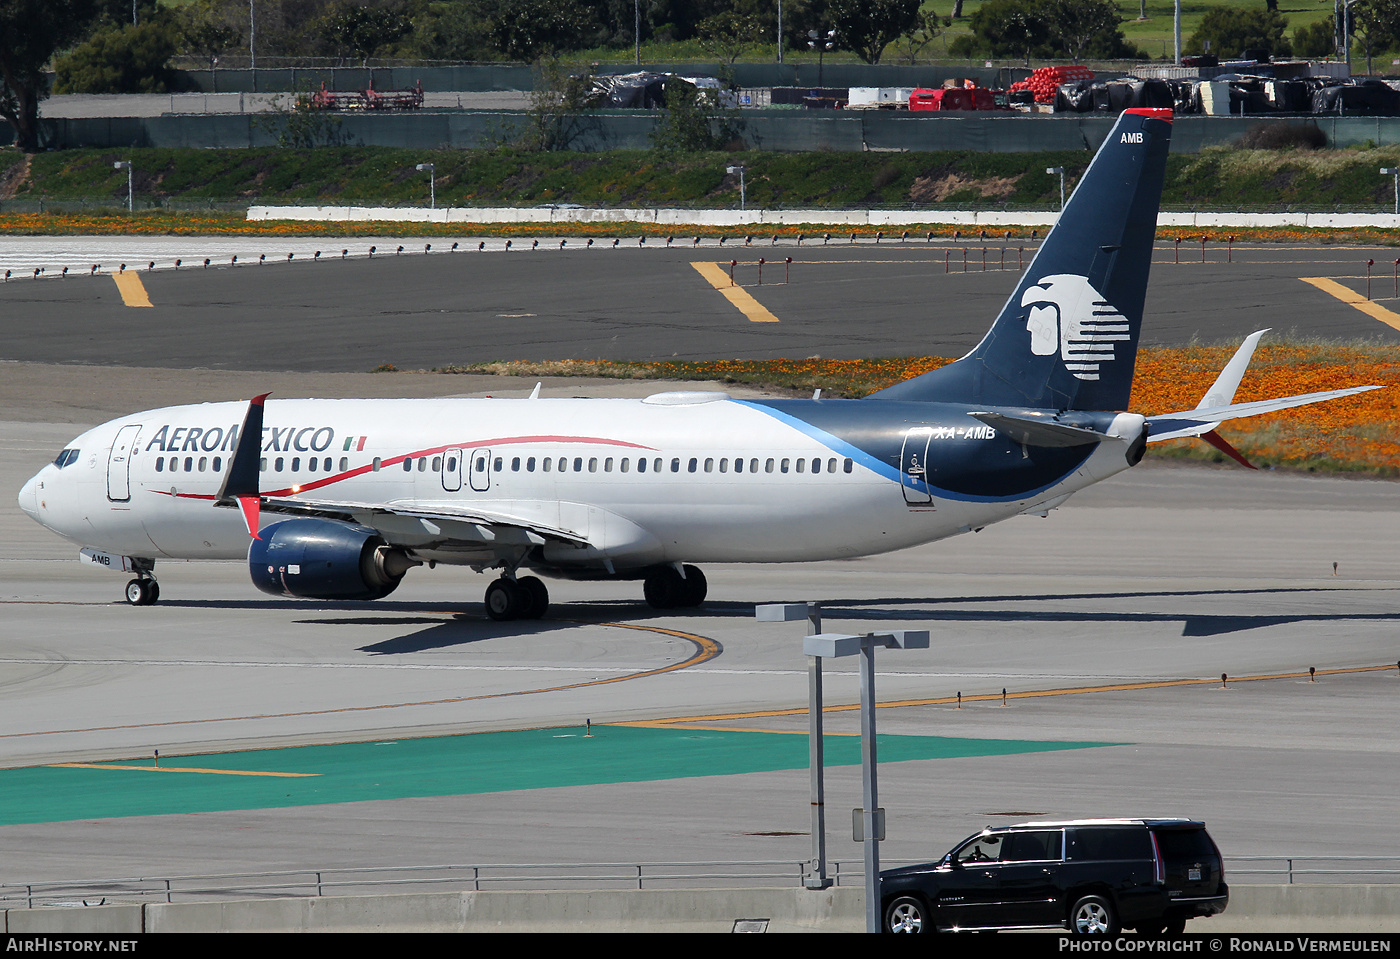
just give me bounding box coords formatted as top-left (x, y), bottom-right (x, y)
top-left (248, 206), bottom-right (1400, 230)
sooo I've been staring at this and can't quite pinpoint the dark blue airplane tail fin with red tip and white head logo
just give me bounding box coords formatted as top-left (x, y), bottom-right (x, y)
top-left (871, 108), bottom-right (1172, 410)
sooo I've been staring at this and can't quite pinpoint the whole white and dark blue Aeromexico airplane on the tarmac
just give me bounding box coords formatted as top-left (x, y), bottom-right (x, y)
top-left (20, 109), bottom-right (1376, 619)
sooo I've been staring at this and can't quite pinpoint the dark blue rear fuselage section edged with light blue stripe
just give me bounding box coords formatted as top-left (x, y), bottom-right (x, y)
top-left (729, 399), bottom-right (1095, 503)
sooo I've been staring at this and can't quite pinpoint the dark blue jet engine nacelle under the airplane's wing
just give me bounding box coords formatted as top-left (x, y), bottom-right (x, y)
top-left (248, 519), bottom-right (419, 599)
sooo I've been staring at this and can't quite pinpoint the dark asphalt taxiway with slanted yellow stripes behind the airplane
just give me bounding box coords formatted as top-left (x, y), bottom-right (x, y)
top-left (0, 237), bottom-right (1400, 372)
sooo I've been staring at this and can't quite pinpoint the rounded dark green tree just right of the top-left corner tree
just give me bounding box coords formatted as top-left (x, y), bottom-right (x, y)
top-left (53, 17), bottom-right (176, 94)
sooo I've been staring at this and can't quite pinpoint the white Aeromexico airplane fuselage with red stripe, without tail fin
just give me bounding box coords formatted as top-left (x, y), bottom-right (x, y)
top-left (20, 393), bottom-right (1141, 571)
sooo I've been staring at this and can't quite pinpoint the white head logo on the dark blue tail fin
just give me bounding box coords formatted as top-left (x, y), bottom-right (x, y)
top-left (1021, 273), bottom-right (1130, 379)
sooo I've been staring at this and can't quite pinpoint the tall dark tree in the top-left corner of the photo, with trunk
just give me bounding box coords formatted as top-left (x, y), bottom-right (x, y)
top-left (0, 0), bottom-right (97, 150)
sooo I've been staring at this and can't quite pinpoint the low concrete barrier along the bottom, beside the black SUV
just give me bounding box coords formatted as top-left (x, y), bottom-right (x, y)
top-left (4, 885), bottom-right (1400, 934)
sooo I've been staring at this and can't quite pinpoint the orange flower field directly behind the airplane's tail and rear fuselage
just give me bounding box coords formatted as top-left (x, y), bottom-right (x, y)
top-left (442, 343), bottom-right (1400, 476)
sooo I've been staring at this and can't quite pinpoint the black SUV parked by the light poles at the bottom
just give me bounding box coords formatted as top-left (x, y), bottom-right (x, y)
top-left (881, 819), bottom-right (1229, 935)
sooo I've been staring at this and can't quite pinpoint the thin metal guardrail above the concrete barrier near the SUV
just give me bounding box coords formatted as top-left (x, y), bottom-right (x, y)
top-left (0, 855), bottom-right (1400, 909)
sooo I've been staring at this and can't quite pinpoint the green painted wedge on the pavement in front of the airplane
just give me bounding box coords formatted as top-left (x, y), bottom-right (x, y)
top-left (0, 725), bottom-right (1112, 825)
